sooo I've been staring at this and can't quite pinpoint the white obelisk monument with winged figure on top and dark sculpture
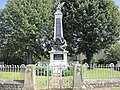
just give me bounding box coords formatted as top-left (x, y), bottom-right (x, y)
top-left (49, 2), bottom-right (68, 66)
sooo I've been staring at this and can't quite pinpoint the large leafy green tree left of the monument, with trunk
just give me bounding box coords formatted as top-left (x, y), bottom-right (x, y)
top-left (0, 0), bottom-right (53, 63)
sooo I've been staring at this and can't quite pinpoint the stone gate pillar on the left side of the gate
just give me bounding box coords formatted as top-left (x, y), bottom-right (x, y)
top-left (23, 64), bottom-right (36, 90)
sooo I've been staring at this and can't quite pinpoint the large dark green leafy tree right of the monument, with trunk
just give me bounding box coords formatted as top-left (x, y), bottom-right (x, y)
top-left (61, 0), bottom-right (120, 64)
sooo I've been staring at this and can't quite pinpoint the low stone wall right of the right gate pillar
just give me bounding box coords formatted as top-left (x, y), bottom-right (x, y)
top-left (83, 79), bottom-right (120, 90)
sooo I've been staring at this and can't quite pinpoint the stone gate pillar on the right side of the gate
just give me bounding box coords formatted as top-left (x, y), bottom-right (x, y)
top-left (73, 64), bottom-right (83, 90)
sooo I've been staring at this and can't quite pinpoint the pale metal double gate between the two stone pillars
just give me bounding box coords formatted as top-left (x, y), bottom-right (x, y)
top-left (36, 65), bottom-right (73, 90)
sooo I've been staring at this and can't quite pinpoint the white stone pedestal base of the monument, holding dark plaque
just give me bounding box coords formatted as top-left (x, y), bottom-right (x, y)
top-left (49, 50), bottom-right (68, 74)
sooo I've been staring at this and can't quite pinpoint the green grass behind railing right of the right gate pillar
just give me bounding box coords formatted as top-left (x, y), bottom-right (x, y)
top-left (82, 68), bottom-right (120, 79)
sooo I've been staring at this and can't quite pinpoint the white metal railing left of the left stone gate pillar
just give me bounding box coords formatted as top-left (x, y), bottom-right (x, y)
top-left (0, 65), bottom-right (25, 80)
